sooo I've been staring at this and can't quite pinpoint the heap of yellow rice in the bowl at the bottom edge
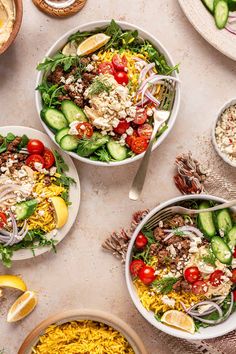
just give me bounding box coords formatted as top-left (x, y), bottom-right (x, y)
top-left (32, 321), bottom-right (134, 354)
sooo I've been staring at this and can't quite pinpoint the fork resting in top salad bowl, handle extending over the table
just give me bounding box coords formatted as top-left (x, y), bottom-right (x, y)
top-left (129, 80), bottom-right (176, 200)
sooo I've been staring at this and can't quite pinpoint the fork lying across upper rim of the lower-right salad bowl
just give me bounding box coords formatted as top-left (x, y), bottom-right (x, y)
top-left (145, 199), bottom-right (236, 230)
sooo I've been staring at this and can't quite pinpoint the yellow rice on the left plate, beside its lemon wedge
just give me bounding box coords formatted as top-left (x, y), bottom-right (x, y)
top-left (27, 173), bottom-right (65, 232)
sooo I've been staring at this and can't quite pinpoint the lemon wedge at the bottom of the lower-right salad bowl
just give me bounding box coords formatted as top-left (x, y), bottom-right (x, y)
top-left (161, 310), bottom-right (195, 334)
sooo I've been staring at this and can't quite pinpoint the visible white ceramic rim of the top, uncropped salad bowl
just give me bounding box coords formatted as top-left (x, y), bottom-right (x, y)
top-left (35, 21), bottom-right (180, 166)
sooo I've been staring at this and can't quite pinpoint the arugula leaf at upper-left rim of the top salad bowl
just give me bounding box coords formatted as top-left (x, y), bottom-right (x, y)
top-left (37, 53), bottom-right (80, 72)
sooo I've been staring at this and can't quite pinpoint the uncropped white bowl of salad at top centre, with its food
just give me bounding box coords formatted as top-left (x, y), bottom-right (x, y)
top-left (36, 20), bottom-right (180, 166)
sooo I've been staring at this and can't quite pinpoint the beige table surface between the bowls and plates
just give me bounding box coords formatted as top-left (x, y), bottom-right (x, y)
top-left (0, 0), bottom-right (236, 354)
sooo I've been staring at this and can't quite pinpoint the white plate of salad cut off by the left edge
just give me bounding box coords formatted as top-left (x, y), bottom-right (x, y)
top-left (0, 126), bottom-right (80, 267)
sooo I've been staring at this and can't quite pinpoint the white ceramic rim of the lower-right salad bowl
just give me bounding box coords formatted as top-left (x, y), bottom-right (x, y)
top-left (125, 194), bottom-right (236, 340)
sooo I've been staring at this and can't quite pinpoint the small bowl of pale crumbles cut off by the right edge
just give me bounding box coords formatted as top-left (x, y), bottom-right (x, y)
top-left (212, 99), bottom-right (236, 167)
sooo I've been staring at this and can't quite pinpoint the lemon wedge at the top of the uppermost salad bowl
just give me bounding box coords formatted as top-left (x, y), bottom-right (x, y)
top-left (77, 33), bottom-right (111, 55)
